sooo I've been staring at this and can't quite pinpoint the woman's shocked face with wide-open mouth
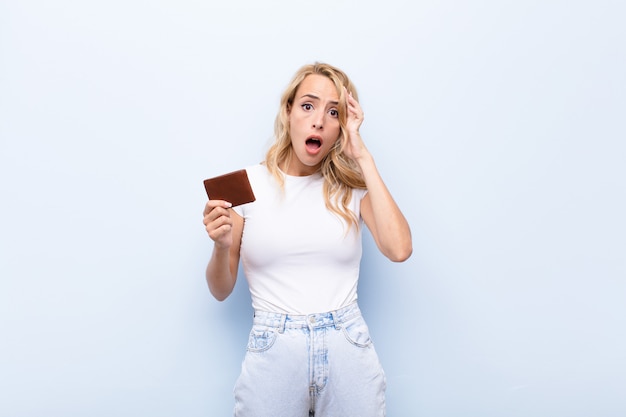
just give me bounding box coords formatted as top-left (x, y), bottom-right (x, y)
top-left (286, 74), bottom-right (340, 176)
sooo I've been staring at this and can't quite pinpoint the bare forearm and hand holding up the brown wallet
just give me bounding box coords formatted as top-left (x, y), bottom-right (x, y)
top-left (203, 200), bottom-right (243, 301)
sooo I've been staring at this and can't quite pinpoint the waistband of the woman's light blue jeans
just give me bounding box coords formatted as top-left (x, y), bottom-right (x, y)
top-left (253, 303), bottom-right (361, 332)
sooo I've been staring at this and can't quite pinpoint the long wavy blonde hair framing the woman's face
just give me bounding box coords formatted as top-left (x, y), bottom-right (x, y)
top-left (265, 62), bottom-right (366, 228)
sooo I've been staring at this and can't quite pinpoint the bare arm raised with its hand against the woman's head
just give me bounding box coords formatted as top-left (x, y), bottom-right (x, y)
top-left (344, 91), bottom-right (413, 262)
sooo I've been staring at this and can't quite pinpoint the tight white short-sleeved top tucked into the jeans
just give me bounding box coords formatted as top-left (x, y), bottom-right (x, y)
top-left (234, 165), bottom-right (367, 314)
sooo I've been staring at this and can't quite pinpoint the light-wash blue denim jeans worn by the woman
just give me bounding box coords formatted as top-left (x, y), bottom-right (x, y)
top-left (234, 303), bottom-right (385, 417)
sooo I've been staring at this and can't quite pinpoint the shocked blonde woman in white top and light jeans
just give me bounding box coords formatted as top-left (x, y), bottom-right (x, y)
top-left (204, 63), bottom-right (412, 417)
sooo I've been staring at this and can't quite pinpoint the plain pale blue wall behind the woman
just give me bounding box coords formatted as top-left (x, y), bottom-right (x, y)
top-left (0, 0), bottom-right (626, 417)
